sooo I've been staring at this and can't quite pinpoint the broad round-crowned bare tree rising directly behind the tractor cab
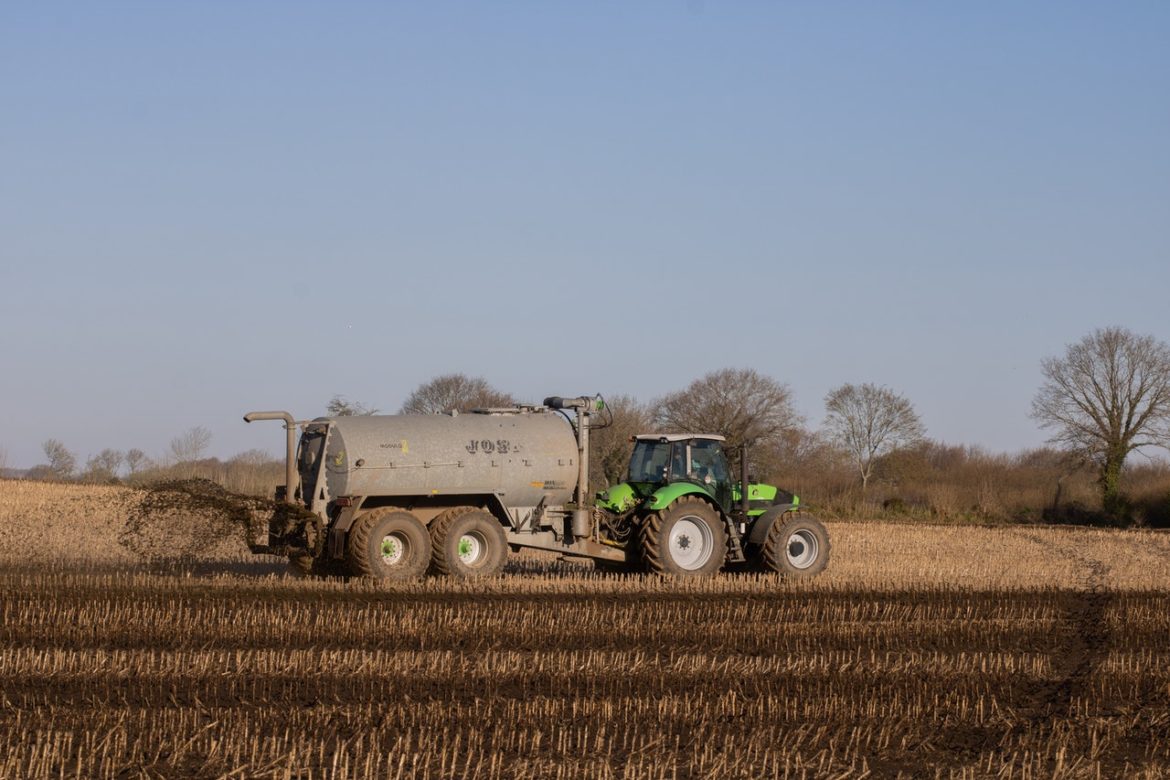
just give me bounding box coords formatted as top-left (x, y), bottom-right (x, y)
top-left (654, 368), bottom-right (800, 460)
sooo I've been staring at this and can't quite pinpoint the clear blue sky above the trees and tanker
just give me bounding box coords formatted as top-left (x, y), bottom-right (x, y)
top-left (0, 0), bottom-right (1170, 467)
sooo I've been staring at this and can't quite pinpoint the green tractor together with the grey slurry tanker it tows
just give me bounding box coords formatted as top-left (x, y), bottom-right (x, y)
top-left (243, 395), bottom-right (830, 579)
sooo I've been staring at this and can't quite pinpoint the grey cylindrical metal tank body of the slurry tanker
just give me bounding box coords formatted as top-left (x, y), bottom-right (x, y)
top-left (318, 410), bottom-right (577, 506)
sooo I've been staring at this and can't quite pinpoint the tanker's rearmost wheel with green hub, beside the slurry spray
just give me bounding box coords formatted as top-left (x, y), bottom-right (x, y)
top-left (345, 506), bottom-right (431, 580)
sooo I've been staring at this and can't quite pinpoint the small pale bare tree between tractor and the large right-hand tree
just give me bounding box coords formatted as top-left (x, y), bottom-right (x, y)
top-left (825, 384), bottom-right (925, 492)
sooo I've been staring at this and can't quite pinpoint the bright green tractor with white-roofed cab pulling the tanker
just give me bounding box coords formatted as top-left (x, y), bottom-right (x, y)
top-left (596, 434), bottom-right (830, 578)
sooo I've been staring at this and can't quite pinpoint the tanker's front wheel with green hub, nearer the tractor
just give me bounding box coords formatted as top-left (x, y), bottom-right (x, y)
top-left (431, 506), bottom-right (508, 580)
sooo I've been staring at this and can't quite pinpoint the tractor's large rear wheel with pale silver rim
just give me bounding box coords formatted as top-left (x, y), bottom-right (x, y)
top-left (639, 498), bottom-right (728, 577)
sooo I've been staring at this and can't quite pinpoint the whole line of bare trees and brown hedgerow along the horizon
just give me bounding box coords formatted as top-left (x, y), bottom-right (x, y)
top-left (16, 327), bottom-right (1170, 524)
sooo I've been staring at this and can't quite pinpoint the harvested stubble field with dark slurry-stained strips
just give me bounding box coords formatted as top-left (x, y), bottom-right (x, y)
top-left (0, 482), bottom-right (1170, 779)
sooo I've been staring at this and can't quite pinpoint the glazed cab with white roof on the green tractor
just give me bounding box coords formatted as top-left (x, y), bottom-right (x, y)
top-left (628, 434), bottom-right (732, 511)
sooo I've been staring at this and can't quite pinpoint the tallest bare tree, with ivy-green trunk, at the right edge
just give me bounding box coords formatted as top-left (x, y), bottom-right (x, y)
top-left (1032, 327), bottom-right (1170, 518)
